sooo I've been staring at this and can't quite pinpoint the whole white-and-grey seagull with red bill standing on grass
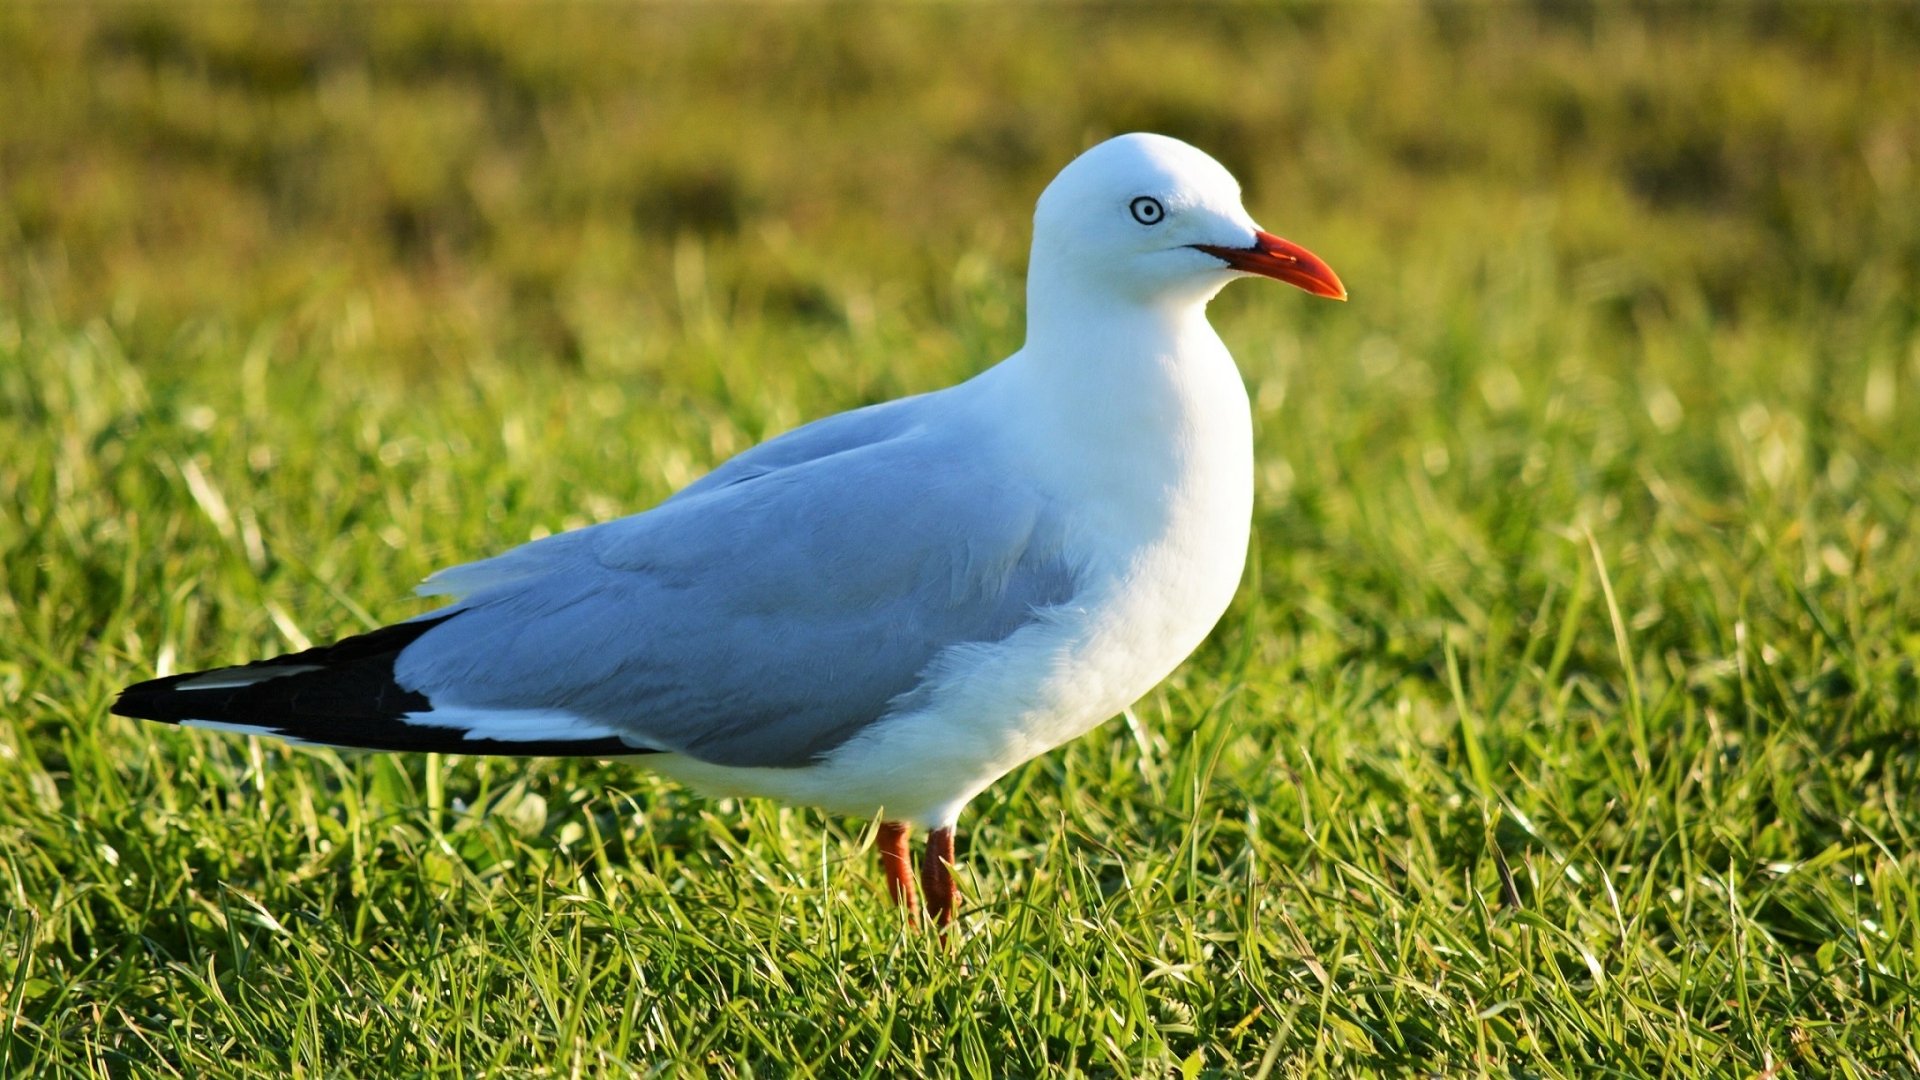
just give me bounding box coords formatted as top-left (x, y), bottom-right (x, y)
top-left (111, 135), bottom-right (1346, 932)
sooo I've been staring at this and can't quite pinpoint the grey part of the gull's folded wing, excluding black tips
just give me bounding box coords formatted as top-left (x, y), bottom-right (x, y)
top-left (394, 427), bottom-right (1073, 767)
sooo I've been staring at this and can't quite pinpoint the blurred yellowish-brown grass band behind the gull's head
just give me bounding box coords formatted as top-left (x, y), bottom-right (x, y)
top-left (0, 4), bottom-right (1920, 365)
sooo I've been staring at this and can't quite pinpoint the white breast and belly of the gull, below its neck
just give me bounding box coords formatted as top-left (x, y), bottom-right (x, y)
top-left (651, 313), bottom-right (1254, 828)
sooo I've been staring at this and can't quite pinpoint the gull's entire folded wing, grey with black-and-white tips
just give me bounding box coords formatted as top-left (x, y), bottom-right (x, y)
top-left (115, 402), bottom-right (1073, 767)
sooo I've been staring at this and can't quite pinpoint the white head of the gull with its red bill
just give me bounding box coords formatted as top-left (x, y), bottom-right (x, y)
top-left (1031, 135), bottom-right (1346, 304)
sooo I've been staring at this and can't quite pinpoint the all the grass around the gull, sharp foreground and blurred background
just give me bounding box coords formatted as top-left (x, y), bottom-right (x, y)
top-left (0, 4), bottom-right (1920, 1076)
